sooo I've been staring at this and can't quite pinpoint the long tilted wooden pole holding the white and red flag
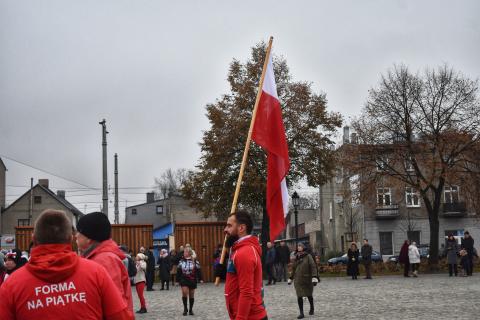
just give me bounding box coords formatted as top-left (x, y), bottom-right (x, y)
top-left (215, 37), bottom-right (273, 286)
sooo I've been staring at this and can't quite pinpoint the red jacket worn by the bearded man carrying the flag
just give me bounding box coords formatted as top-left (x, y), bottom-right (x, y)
top-left (225, 236), bottom-right (267, 320)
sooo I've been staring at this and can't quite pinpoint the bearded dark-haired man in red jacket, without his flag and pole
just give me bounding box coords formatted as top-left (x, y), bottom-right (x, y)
top-left (217, 211), bottom-right (268, 320)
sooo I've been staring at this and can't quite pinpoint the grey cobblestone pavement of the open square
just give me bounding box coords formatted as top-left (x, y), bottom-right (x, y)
top-left (133, 275), bottom-right (480, 320)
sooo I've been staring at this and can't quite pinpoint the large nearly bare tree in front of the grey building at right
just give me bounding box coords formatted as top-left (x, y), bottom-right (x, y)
top-left (342, 66), bottom-right (480, 268)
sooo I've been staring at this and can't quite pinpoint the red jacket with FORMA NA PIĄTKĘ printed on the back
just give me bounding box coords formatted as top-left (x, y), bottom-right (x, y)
top-left (0, 244), bottom-right (134, 320)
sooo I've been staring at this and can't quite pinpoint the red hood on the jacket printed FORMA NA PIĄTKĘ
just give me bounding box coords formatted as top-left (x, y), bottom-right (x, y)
top-left (25, 244), bottom-right (80, 283)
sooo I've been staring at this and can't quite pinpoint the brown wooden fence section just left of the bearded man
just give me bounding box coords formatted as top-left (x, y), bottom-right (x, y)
top-left (174, 222), bottom-right (226, 282)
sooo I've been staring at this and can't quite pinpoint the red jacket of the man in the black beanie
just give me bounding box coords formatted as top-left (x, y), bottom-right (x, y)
top-left (85, 239), bottom-right (133, 312)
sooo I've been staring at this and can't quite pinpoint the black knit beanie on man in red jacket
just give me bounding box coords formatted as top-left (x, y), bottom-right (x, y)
top-left (77, 212), bottom-right (112, 242)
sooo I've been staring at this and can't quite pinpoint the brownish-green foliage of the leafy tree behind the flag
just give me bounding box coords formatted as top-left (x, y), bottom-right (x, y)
top-left (183, 43), bottom-right (342, 218)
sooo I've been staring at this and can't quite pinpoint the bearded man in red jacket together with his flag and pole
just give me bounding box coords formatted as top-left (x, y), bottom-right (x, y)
top-left (217, 38), bottom-right (290, 320)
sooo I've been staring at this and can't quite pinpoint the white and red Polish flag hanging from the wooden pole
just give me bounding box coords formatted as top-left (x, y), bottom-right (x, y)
top-left (252, 51), bottom-right (290, 241)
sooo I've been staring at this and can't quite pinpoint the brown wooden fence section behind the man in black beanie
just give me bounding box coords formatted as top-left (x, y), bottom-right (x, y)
top-left (15, 224), bottom-right (153, 253)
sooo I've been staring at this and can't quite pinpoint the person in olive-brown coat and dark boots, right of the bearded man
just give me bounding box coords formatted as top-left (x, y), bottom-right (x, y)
top-left (288, 242), bottom-right (318, 319)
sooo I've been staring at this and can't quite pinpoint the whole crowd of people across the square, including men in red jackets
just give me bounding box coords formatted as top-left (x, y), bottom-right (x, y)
top-left (0, 210), bottom-right (476, 320)
